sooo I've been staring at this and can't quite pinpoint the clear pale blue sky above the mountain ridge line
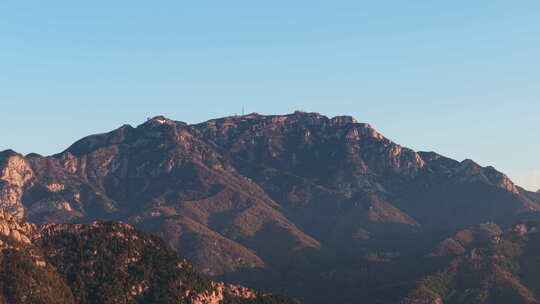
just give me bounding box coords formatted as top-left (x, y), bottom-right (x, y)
top-left (0, 0), bottom-right (540, 190)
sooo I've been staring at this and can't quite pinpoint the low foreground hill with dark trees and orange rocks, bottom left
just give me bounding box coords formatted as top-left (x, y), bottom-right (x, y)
top-left (0, 211), bottom-right (296, 304)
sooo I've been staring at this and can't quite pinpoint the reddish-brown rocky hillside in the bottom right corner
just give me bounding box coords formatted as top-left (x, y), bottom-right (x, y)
top-left (401, 221), bottom-right (540, 304)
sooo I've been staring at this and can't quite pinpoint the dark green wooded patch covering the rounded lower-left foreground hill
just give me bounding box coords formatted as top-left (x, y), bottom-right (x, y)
top-left (43, 223), bottom-right (210, 304)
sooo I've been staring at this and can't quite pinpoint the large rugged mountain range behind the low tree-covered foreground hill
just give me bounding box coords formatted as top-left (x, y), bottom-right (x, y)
top-left (0, 111), bottom-right (540, 303)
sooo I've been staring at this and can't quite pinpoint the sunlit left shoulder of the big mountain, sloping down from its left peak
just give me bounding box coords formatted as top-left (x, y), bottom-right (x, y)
top-left (0, 118), bottom-right (320, 274)
